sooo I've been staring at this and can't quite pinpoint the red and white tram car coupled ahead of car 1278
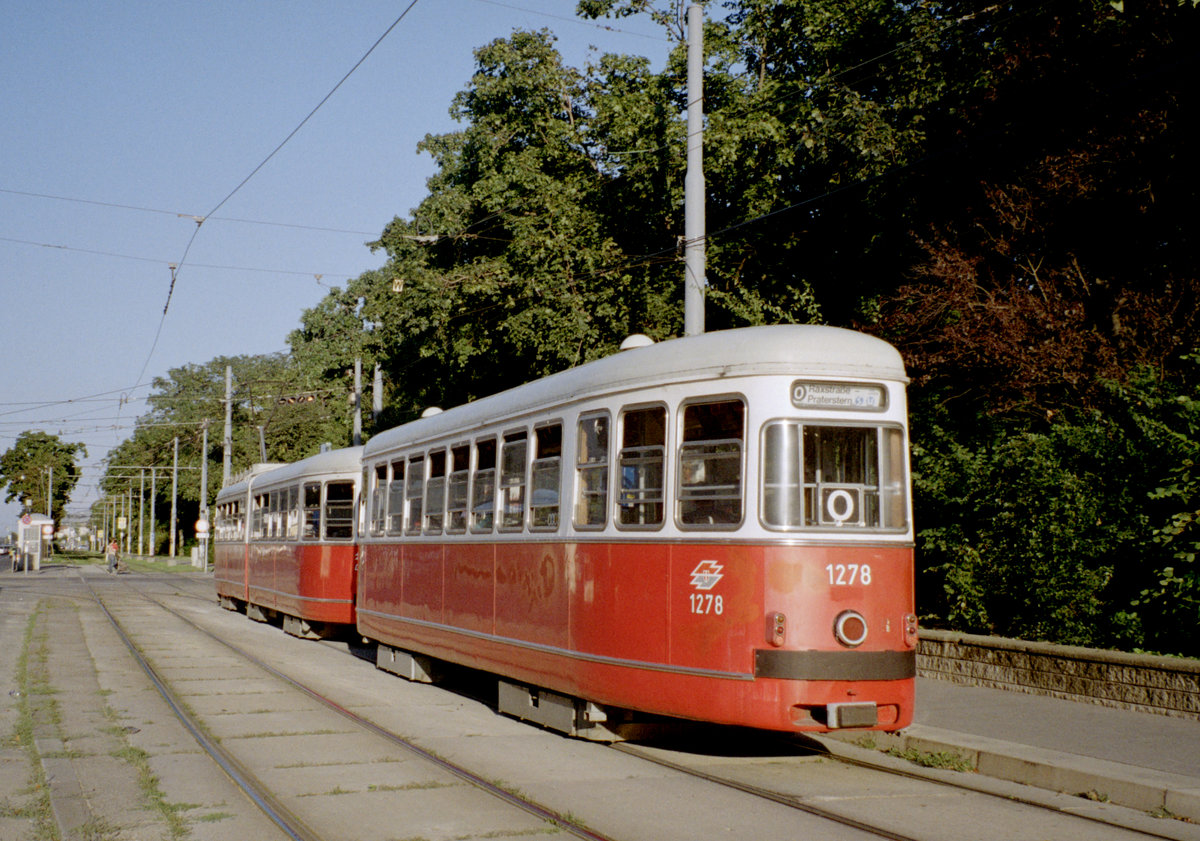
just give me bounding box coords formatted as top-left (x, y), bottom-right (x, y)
top-left (215, 447), bottom-right (362, 637)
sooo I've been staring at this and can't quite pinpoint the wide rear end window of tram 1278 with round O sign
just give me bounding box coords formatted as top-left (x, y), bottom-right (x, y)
top-left (762, 422), bottom-right (906, 529)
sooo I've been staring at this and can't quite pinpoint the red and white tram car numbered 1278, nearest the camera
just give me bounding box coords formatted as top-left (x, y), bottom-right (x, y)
top-left (357, 326), bottom-right (917, 739)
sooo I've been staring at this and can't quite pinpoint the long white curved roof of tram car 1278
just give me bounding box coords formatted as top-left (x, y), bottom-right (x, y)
top-left (364, 324), bottom-right (907, 457)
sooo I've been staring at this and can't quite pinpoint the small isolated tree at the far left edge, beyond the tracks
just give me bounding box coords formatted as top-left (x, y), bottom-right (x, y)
top-left (0, 432), bottom-right (88, 522)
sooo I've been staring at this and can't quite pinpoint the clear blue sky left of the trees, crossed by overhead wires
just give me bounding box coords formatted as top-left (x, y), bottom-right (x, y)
top-left (0, 0), bottom-right (670, 531)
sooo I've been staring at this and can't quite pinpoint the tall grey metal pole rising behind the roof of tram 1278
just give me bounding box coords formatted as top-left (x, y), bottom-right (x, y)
top-left (683, 4), bottom-right (708, 336)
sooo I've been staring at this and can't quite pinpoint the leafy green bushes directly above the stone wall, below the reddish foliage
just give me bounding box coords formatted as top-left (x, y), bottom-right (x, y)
top-left (913, 359), bottom-right (1200, 656)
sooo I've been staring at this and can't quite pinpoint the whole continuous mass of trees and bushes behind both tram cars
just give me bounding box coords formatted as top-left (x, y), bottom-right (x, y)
top-left (75, 0), bottom-right (1200, 654)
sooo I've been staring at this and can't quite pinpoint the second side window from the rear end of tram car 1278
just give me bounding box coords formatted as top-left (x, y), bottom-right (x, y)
top-left (617, 408), bottom-right (667, 527)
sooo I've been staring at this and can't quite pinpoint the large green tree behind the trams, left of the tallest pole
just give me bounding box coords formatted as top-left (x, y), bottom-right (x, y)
top-left (302, 31), bottom-right (678, 419)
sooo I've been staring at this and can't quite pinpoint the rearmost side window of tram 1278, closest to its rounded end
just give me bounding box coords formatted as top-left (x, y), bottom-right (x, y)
top-left (678, 400), bottom-right (745, 528)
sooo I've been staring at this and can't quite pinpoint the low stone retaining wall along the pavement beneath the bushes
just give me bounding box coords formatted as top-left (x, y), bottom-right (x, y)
top-left (917, 630), bottom-right (1200, 719)
